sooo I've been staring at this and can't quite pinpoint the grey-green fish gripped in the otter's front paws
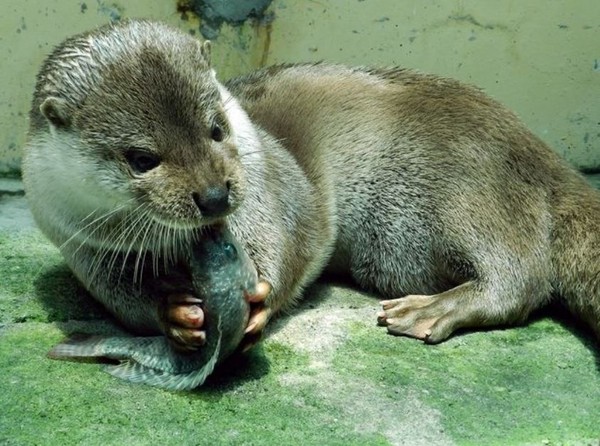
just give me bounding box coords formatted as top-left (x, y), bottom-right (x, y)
top-left (48, 226), bottom-right (258, 391)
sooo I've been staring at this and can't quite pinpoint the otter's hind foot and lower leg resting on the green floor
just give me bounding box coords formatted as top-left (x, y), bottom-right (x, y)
top-left (378, 280), bottom-right (542, 344)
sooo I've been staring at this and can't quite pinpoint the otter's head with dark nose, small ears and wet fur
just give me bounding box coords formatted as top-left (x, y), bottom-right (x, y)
top-left (31, 21), bottom-right (250, 246)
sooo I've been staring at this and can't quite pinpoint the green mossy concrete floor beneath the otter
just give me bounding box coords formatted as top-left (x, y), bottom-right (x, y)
top-left (0, 176), bottom-right (600, 446)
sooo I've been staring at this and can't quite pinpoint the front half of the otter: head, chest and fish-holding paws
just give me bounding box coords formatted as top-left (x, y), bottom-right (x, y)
top-left (22, 21), bottom-right (324, 351)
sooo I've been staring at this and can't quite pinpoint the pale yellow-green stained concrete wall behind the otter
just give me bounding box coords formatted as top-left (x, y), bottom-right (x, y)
top-left (0, 0), bottom-right (600, 172)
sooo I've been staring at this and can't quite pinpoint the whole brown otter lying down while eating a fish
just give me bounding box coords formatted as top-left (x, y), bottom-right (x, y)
top-left (23, 21), bottom-right (600, 358)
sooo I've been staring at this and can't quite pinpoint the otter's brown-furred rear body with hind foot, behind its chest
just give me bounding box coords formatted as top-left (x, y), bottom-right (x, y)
top-left (227, 64), bottom-right (600, 342)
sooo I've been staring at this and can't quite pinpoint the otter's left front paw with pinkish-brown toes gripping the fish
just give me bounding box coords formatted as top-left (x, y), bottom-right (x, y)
top-left (160, 294), bottom-right (206, 352)
